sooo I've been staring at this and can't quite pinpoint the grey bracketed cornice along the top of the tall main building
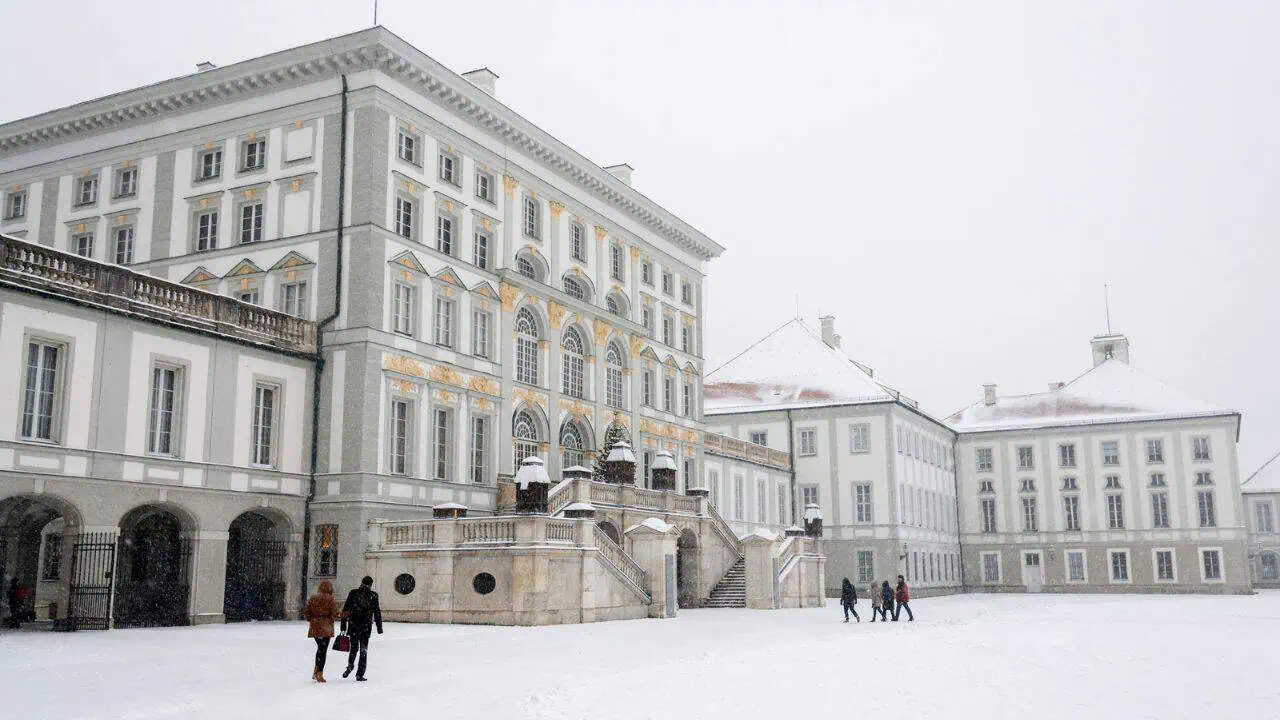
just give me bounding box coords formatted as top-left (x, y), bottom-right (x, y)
top-left (0, 27), bottom-right (724, 260)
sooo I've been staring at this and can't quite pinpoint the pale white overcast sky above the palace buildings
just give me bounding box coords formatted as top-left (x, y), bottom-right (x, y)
top-left (0, 0), bottom-right (1280, 478)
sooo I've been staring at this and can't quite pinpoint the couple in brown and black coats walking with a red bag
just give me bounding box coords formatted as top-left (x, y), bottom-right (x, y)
top-left (302, 575), bottom-right (383, 683)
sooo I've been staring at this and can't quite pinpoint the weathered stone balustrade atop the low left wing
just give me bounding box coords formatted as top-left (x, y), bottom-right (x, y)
top-left (0, 234), bottom-right (316, 354)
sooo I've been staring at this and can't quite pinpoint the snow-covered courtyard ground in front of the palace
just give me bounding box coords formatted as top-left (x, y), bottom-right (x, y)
top-left (0, 592), bottom-right (1280, 720)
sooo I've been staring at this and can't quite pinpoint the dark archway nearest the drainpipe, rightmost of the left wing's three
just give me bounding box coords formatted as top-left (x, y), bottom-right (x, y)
top-left (223, 510), bottom-right (289, 623)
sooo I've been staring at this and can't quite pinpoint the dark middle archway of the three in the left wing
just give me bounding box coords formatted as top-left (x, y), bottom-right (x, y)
top-left (114, 505), bottom-right (195, 628)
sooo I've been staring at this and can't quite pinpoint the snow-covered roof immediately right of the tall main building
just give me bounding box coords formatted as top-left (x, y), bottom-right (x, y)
top-left (703, 318), bottom-right (899, 415)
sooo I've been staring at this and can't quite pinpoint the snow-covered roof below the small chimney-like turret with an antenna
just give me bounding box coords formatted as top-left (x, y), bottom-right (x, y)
top-left (946, 359), bottom-right (1236, 433)
